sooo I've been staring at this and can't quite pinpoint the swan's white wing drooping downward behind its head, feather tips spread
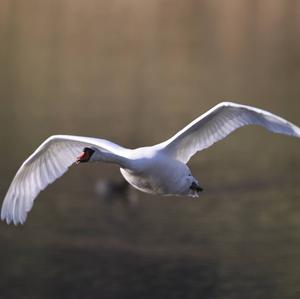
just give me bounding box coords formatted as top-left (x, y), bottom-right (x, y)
top-left (1, 135), bottom-right (123, 224)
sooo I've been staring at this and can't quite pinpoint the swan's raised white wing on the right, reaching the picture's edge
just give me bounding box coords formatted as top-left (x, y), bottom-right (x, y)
top-left (160, 102), bottom-right (300, 163)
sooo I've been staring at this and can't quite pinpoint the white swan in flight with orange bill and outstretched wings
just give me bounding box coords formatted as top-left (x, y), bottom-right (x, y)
top-left (1, 102), bottom-right (300, 224)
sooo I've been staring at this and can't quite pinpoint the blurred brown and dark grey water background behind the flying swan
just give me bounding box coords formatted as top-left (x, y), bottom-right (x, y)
top-left (0, 0), bottom-right (300, 299)
